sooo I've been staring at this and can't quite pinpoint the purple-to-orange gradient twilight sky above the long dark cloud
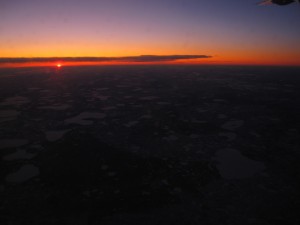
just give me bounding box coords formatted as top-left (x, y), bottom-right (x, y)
top-left (0, 0), bottom-right (300, 65)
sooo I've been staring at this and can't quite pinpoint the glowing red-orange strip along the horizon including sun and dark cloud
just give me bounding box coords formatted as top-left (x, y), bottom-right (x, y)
top-left (0, 54), bottom-right (300, 68)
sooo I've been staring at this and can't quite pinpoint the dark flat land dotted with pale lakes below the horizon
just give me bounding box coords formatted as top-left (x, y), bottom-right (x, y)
top-left (0, 66), bottom-right (300, 225)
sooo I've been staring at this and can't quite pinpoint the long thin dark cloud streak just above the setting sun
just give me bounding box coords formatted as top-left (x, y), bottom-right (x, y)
top-left (0, 55), bottom-right (211, 63)
